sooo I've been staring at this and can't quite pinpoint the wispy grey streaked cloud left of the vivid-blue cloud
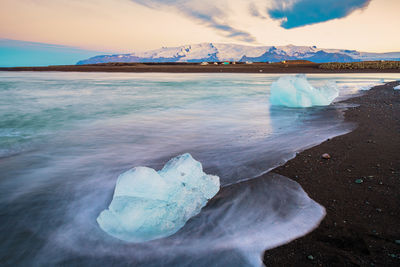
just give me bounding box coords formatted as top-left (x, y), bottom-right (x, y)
top-left (131, 0), bottom-right (256, 42)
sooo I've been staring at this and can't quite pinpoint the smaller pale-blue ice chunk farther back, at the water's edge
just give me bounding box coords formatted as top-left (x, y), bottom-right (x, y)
top-left (270, 74), bottom-right (339, 107)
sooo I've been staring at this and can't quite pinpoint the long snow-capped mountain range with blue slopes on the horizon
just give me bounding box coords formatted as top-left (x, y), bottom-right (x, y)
top-left (77, 43), bottom-right (400, 65)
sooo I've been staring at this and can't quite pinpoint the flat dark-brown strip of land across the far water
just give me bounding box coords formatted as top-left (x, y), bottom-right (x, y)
top-left (0, 63), bottom-right (400, 74)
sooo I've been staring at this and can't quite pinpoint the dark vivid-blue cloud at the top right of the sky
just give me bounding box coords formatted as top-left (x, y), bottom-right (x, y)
top-left (268, 0), bottom-right (371, 29)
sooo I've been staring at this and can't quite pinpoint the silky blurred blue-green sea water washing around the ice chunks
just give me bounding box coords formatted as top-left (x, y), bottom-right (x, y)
top-left (0, 72), bottom-right (399, 266)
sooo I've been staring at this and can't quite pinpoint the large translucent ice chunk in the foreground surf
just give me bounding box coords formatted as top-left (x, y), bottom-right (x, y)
top-left (97, 154), bottom-right (220, 242)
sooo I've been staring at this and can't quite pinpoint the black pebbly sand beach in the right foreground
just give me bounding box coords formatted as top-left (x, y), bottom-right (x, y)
top-left (259, 81), bottom-right (400, 266)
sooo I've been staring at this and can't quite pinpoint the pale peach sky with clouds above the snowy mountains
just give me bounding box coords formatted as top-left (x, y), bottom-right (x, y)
top-left (0, 0), bottom-right (400, 64)
